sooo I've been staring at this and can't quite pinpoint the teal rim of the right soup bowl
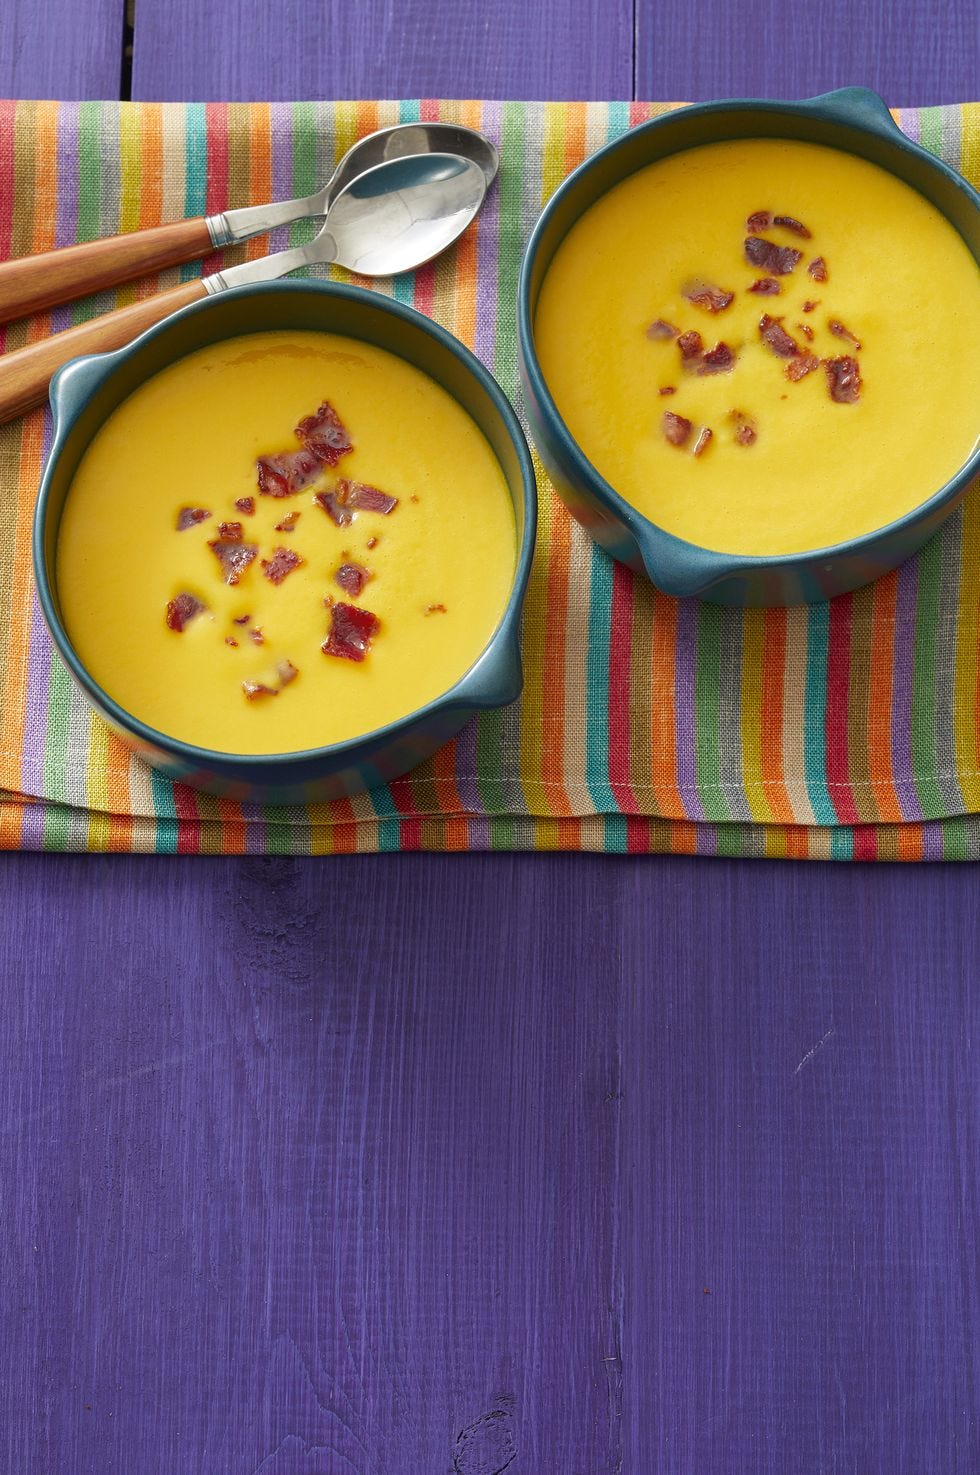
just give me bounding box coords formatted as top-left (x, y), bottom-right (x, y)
top-left (517, 87), bottom-right (980, 597)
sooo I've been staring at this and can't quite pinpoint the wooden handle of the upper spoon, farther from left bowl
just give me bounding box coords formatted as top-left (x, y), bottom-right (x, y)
top-left (0, 215), bottom-right (214, 323)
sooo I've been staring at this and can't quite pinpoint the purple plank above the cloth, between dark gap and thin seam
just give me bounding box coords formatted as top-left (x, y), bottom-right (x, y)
top-left (133, 0), bottom-right (633, 102)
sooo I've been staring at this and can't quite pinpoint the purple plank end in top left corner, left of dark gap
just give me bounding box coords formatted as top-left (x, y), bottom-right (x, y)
top-left (0, 0), bottom-right (124, 99)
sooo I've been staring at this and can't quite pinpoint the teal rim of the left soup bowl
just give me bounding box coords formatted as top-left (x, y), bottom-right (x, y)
top-left (31, 277), bottom-right (537, 771)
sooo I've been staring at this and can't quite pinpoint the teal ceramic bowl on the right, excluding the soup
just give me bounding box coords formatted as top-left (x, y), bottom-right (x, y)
top-left (518, 87), bottom-right (980, 605)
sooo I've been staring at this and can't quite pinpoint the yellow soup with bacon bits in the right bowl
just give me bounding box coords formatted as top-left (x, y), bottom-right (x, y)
top-left (534, 139), bottom-right (980, 555)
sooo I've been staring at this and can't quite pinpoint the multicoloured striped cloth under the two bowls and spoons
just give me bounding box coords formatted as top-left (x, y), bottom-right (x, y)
top-left (0, 102), bottom-right (980, 860)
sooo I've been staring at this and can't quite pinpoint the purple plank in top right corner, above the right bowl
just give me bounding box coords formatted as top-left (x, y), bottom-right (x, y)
top-left (636, 0), bottom-right (980, 108)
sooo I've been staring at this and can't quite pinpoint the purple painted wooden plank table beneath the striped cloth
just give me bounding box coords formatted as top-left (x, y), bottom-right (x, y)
top-left (0, 0), bottom-right (980, 1475)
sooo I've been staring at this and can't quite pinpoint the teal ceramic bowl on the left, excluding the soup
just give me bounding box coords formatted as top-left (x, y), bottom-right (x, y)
top-left (34, 282), bottom-right (537, 804)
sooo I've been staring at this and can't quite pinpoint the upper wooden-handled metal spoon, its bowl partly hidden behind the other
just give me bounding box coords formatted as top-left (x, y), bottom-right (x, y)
top-left (0, 122), bottom-right (497, 323)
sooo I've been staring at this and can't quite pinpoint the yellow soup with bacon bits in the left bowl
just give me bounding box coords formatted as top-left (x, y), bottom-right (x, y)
top-left (58, 332), bottom-right (515, 754)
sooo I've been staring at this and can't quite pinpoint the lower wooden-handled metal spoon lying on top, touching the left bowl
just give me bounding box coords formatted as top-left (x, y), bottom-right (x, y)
top-left (0, 153), bottom-right (487, 422)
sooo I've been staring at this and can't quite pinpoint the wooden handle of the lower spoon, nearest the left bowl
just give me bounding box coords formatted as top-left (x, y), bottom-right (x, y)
top-left (0, 280), bottom-right (208, 423)
